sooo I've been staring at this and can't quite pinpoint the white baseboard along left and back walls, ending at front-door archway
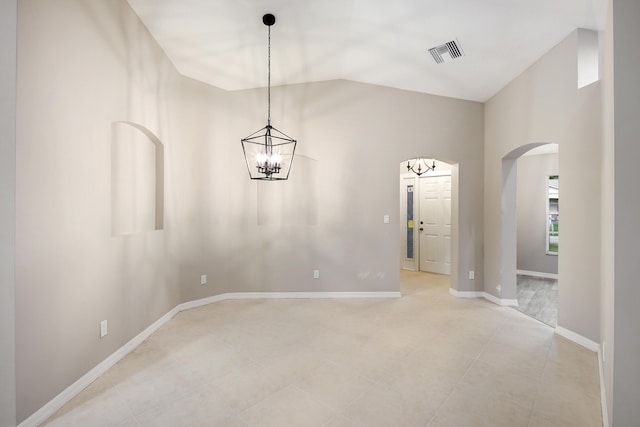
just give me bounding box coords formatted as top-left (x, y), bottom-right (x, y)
top-left (18, 292), bottom-right (401, 427)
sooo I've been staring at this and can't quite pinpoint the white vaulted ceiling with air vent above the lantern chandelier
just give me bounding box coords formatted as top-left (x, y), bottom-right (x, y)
top-left (129, 0), bottom-right (607, 101)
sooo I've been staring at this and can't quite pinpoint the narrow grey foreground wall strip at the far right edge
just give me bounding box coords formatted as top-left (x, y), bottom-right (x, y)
top-left (607, 0), bottom-right (640, 427)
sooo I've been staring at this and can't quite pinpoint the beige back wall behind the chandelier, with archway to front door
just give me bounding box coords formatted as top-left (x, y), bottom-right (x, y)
top-left (178, 80), bottom-right (483, 301)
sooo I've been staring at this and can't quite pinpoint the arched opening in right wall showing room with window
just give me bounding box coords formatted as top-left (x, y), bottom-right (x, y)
top-left (500, 143), bottom-right (559, 327)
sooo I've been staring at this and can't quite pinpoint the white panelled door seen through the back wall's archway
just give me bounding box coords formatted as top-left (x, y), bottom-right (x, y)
top-left (418, 175), bottom-right (451, 274)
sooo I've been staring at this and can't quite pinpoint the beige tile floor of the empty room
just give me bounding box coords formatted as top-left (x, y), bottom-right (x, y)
top-left (45, 271), bottom-right (602, 427)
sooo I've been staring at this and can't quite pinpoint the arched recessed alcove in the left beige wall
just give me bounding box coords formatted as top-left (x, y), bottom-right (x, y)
top-left (111, 121), bottom-right (164, 236)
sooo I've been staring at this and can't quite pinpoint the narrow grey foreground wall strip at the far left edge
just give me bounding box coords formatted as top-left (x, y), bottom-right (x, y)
top-left (0, 0), bottom-right (17, 426)
